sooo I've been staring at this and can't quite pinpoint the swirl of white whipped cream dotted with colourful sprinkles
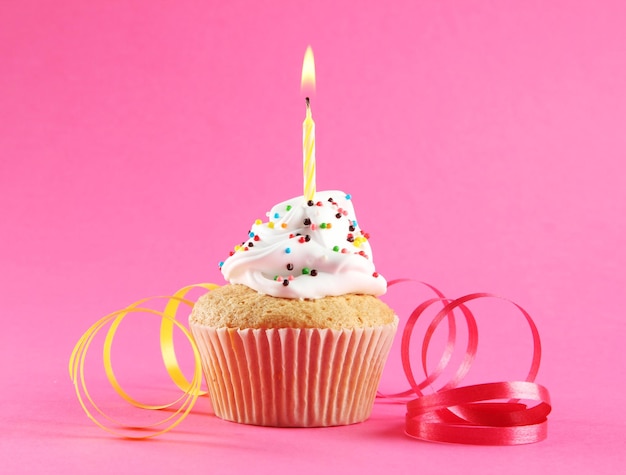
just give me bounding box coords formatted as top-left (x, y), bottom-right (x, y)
top-left (220, 191), bottom-right (387, 299)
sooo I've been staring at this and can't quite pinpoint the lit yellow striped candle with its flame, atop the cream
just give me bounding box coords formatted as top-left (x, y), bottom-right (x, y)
top-left (300, 46), bottom-right (315, 201)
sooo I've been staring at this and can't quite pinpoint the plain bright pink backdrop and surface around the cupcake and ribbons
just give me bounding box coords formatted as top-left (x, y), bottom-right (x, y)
top-left (0, 0), bottom-right (626, 474)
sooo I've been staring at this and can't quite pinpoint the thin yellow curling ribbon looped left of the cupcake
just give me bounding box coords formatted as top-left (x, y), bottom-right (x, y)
top-left (69, 283), bottom-right (219, 439)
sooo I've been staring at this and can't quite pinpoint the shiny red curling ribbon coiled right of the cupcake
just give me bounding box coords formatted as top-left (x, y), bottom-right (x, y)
top-left (379, 279), bottom-right (551, 445)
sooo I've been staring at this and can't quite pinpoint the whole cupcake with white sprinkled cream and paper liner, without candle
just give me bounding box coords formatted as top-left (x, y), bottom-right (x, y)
top-left (189, 191), bottom-right (398, 427)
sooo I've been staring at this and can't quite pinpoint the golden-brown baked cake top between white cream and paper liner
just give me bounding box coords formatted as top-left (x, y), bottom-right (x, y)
top-left (189, 284), bottom-right (397, 330)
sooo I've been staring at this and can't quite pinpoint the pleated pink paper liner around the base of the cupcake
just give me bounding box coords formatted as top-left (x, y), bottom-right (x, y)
top-left (191, 321), bottom-right (397, 427)
